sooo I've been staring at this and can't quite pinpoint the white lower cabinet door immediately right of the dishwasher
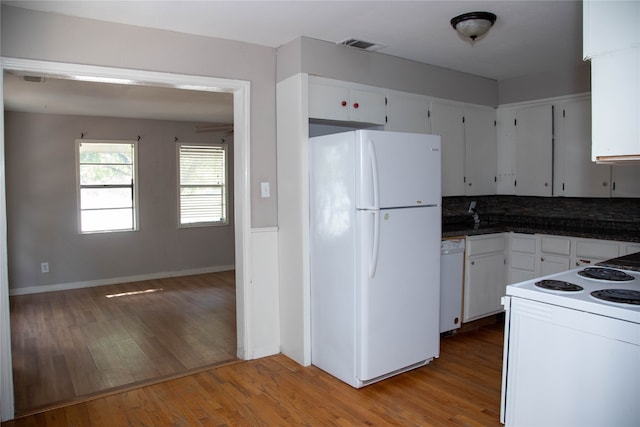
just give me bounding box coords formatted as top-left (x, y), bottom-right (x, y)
top-left (462, 233), bottom-right (505, 322)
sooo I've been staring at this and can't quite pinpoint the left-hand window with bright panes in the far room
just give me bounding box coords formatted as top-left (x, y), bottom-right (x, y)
top-left (76, 139), bottom-right (138, 233)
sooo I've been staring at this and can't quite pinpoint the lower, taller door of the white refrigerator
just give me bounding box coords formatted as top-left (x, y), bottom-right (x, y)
top-left (356, 207), bottom-right (441, 382)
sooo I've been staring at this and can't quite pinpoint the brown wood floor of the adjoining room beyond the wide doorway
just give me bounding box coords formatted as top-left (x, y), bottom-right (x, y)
top-left (10, 271), bottom-right (237, 414)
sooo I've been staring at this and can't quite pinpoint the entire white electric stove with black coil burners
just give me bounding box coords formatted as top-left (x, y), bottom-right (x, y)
top-left (501, 262), bottom-right (640, 427)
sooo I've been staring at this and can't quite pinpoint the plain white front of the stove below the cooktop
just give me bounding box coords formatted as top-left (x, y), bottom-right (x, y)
top-left (501, 297), bottom-right (640, 427)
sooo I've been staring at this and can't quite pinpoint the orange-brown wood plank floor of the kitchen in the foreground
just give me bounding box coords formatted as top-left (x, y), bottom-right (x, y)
top-left (2, 323), bottom-right (503, 427)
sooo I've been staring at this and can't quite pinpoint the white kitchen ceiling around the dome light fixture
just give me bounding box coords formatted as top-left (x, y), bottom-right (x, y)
top-left (3, 0), bottom-right (582, 122)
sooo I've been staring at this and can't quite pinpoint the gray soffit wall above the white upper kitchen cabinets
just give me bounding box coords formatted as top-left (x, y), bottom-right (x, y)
top-left (277, 37), bottom-right (591, 107)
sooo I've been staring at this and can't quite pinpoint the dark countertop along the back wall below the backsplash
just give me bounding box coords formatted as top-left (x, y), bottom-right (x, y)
top-left (442, 215), bottom-right (640, 242)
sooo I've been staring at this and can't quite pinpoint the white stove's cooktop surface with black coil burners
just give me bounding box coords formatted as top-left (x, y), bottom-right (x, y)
top-left (507, 266), bottom-right (640, 323)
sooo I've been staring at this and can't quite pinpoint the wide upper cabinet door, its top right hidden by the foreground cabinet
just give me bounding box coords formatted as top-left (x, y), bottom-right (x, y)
top-left (554, 99), bottom-right (611, 197)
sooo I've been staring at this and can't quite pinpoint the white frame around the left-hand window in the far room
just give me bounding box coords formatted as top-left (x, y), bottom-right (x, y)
top-left (75, 138), bottom-right (140, 234)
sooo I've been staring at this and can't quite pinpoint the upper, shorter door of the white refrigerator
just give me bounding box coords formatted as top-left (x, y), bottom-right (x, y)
top-left (355, 130), bottom-right (441, 209)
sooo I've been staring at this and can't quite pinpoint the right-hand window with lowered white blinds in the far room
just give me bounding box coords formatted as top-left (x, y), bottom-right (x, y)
top-left (178, 143), bottom-right (227, 227)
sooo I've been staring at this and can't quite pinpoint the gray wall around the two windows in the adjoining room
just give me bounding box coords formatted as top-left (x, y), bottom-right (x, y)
top-left (5, 112), bottom-right (235, 289)
